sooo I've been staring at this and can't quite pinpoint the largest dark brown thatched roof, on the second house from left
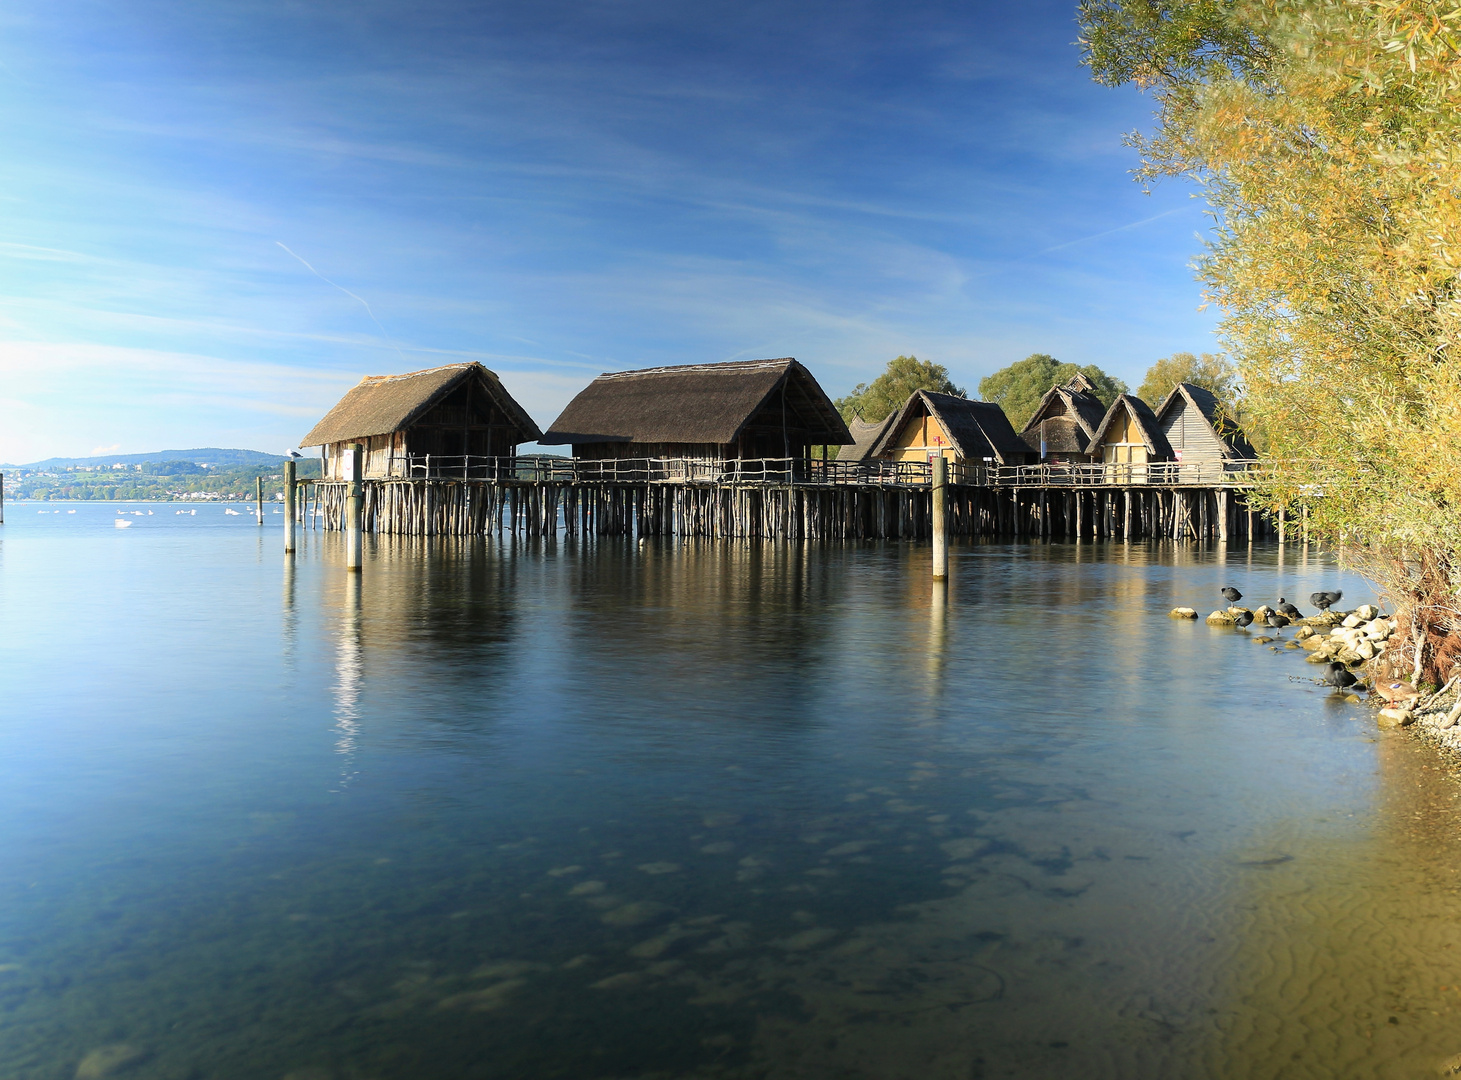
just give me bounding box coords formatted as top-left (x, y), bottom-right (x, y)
top-left (542, 357), bottom-right (852, 446)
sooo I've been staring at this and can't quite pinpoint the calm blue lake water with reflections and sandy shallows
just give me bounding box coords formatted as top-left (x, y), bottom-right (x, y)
top-left (0, 503), bottom-right (1461, 1080)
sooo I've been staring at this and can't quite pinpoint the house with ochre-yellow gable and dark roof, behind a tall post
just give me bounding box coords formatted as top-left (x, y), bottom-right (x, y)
top-left (871, 390), bottom-right (1034, 465)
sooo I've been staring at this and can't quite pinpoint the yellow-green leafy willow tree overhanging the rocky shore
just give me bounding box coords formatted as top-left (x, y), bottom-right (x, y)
top-left (1081, 0), bottom-right (1461, 681)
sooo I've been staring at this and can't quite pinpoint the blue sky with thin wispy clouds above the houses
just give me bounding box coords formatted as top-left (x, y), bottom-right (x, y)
top-left (0, 0), bottom-right (1216, 462)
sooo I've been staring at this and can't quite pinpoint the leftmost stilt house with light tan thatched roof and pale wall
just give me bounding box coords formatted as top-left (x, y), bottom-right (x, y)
top-left (300, 364), bottom-right (542, 479)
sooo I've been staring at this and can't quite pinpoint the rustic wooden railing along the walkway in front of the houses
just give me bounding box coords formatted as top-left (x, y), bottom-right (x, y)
top-left (356, 455), bottom-right (1264, 488)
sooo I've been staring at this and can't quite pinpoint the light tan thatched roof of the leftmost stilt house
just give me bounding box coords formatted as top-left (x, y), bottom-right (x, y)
top-left (300, 362), bottom-right (542, 446)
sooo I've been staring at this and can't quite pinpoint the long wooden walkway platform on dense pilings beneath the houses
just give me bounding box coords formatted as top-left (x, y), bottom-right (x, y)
top-left (302, 457), bottom-right (1278, 541)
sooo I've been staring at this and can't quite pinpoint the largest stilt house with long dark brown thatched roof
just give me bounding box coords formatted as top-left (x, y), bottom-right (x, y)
top-left (542, 358), bottom-right (852, 460)
